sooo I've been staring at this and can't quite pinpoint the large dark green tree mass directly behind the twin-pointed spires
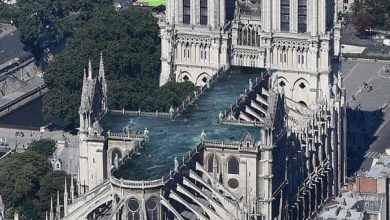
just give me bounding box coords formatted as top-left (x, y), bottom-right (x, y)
top-left (43, 7), bottom-right (194, 125)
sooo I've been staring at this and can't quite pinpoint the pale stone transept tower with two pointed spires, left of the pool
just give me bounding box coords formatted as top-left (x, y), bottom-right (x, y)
top-left (79, 55), bottom-right (107, 193)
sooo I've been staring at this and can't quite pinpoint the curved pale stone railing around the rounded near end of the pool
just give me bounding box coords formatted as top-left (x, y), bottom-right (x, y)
top-left (110, 176), bottom-right (165, 189)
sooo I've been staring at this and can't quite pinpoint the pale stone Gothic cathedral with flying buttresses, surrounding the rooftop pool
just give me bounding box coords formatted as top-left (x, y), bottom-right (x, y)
top-left (56, 0), bottom-right (346, 220)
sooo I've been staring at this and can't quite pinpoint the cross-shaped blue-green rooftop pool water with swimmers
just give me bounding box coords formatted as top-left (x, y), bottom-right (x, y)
top-left (101, 69), bottom-right (260, 180)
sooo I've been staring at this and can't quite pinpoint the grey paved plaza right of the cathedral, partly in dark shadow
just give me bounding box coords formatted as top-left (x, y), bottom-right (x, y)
top-left (342, 61), bottom-right (390, 170)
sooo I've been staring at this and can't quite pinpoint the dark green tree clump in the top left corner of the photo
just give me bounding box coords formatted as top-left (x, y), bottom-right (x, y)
top-left (0, 0), bottom-right (113, 56)
